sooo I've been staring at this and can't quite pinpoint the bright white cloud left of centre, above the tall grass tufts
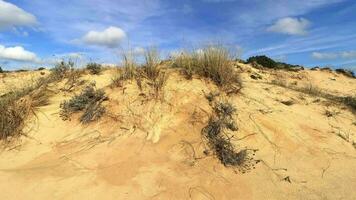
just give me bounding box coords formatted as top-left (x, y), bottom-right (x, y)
top-left (81, 26), bottom-right (126, 48)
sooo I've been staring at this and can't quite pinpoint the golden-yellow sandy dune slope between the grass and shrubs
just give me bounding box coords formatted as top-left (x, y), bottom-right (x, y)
top-left (0, 64), bottom-right (356, 200)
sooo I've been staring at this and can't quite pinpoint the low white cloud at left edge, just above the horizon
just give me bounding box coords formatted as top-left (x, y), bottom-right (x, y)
top-left (0, 45), bottom-right (38, 62)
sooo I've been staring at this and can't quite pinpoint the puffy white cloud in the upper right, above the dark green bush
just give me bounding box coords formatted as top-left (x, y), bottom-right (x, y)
top-left (267, 17), bottom-right (310, 35)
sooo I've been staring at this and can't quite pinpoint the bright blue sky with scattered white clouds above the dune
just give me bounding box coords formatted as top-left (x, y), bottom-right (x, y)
top-left (0, 0), bottom-right (356, 71)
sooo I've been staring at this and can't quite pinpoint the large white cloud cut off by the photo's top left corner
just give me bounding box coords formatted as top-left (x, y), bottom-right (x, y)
top-left (0, 0), bottom-right (37, 29)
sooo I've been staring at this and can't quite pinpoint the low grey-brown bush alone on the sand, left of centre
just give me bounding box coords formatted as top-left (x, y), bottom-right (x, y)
top-left (60, 84), bottom-right (107, 123)
